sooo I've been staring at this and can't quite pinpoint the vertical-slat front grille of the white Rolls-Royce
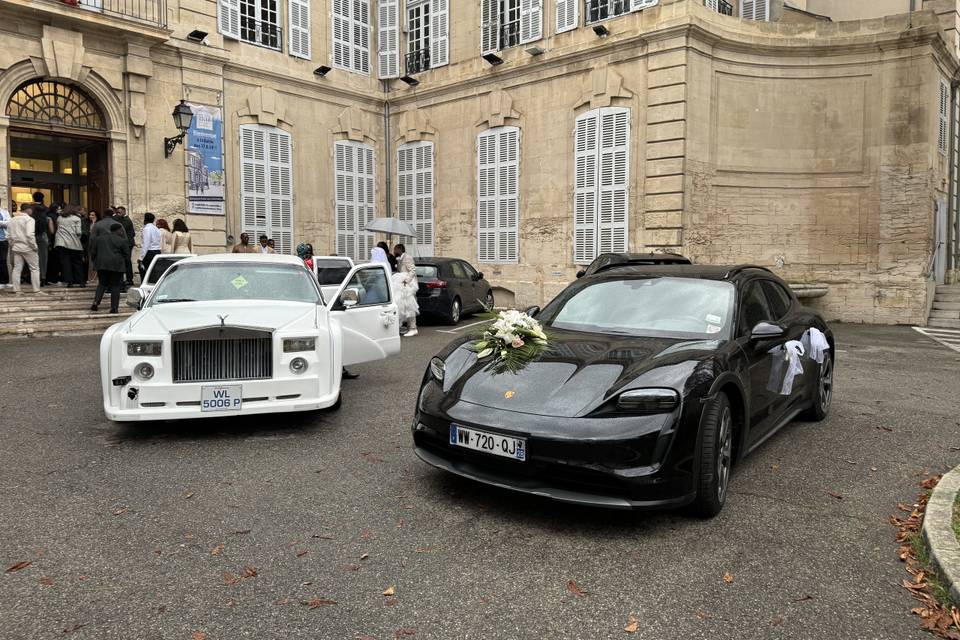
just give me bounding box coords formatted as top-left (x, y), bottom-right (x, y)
top-left (173, 336), bottom-right (273, 382)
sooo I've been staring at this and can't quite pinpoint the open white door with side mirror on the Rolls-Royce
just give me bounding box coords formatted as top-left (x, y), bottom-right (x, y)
top-left (329, 264), bottom-right (400, 366)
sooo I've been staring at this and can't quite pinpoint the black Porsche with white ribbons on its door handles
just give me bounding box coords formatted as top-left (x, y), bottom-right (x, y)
top-left (413, 265), bottom-right (835, 517)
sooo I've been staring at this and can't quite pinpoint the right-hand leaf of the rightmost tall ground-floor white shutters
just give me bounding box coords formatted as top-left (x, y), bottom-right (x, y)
top-left (597, 107), bottom-right (630, 253)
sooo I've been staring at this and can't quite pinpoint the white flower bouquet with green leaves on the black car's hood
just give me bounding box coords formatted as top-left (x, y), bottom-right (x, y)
top-left (467, 309), bottom-right (550, 373)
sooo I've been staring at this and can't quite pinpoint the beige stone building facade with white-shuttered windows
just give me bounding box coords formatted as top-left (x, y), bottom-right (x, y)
top-left (0, 0), bottom-right (960, 323)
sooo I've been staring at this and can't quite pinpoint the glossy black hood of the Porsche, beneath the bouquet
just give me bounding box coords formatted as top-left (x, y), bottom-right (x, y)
top-left (444, 330), bottom-right (721, 417)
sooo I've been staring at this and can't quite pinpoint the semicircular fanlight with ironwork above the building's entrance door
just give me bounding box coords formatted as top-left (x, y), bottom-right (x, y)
top-left (7, 80), bottom-right (107, 131)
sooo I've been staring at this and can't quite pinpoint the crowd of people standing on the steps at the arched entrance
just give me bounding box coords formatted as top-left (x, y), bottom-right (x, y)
top-left (0, 191), bottom-right (193, 313)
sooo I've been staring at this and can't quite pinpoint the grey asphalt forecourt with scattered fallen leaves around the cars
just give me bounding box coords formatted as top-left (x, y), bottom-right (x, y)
top-left (0, 320), bottom-right (960, 640)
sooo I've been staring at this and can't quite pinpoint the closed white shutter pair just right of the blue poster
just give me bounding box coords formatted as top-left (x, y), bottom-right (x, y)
top-left (240, 124), bottom-right (293, 253)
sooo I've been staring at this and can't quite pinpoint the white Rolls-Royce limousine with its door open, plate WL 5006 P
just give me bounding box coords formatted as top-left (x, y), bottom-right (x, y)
top-left (100, 254), bottom-right (400, 422)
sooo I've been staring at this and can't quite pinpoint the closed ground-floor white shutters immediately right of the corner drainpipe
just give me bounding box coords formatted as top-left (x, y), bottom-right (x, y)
top-left (397, 142), bottom-right (435, 256)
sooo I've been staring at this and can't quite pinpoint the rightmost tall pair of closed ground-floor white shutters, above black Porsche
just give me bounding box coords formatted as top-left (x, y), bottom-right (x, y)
top-left (573, 107), bottom-right (630, 264)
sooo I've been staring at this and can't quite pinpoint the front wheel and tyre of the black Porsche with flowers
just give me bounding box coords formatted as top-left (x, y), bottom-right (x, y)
top-left (693, 393), bottom-right (734, 518)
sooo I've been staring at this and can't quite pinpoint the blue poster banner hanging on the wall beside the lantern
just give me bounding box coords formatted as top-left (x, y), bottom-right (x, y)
top-left (186, 103), bottom-right (224, 216)
